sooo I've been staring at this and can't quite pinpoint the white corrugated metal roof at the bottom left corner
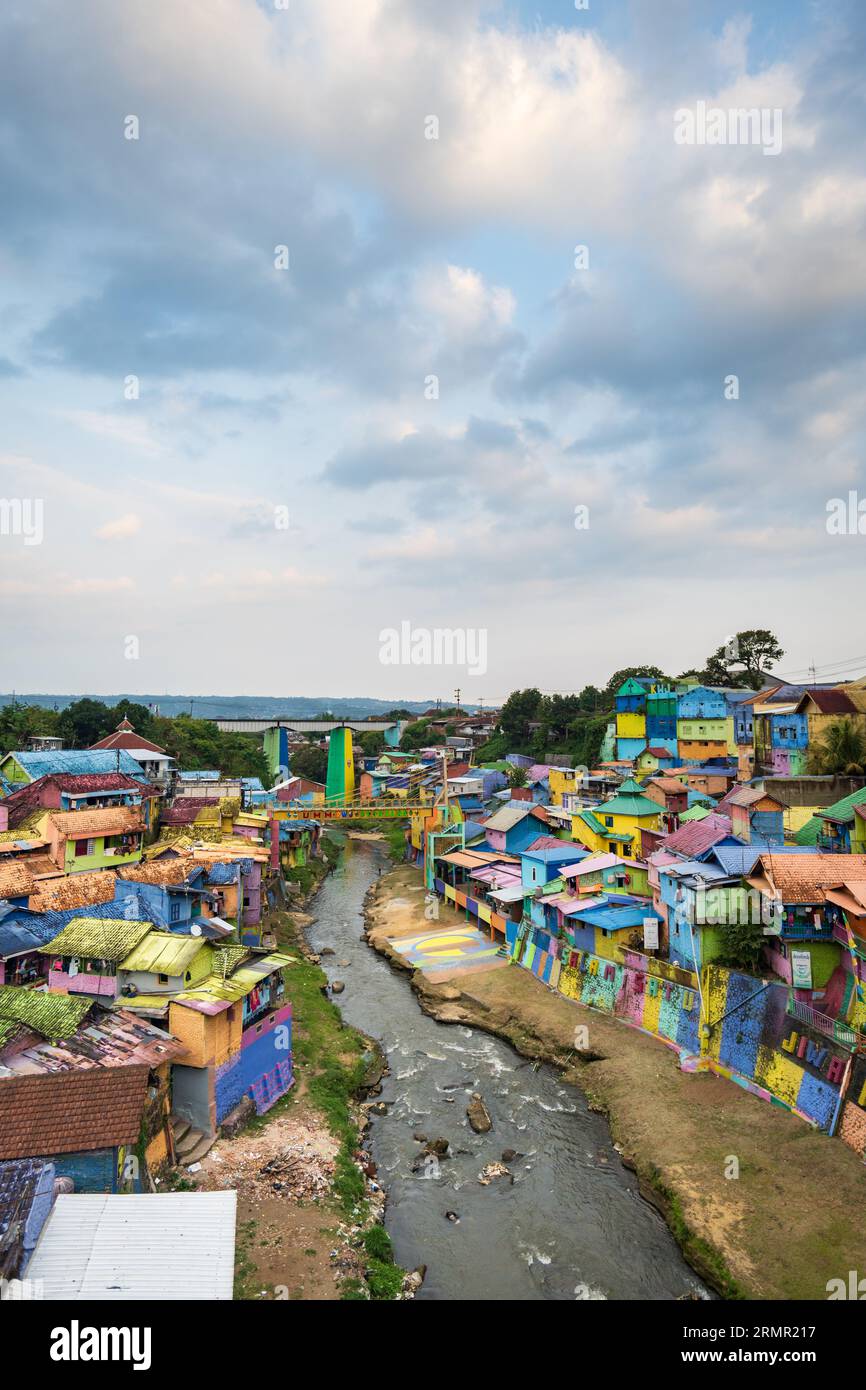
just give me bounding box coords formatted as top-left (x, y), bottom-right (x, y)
top-left (26, 1191), bottom-right (238, 1301)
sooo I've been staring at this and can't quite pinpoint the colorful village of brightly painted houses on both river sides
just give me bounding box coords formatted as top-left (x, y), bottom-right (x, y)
top-left (0, 671), bottom-right (866, 1300)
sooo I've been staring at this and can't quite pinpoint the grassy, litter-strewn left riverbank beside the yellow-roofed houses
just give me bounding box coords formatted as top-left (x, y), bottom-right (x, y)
top-left (179, 847), bottom-right (420, 1301)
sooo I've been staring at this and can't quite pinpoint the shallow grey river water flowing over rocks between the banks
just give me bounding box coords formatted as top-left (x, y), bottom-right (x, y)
top-left (307, 840), bottom-right (706, 1300)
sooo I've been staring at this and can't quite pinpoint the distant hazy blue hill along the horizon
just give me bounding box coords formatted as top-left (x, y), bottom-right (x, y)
top-left (0, 691), bottom-right (477, 719)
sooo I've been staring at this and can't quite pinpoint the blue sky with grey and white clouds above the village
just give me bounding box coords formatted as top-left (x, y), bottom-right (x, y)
top-left (0, 0), bottom-right (866, 705)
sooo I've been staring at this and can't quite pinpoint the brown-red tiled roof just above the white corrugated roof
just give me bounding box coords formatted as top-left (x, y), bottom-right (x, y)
top-left (0, 1066), bottom-right (150, 1159)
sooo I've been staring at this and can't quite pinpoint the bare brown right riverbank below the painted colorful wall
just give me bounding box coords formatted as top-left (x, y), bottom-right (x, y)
top-left (366, 865), bottom-right (866, 1300)
